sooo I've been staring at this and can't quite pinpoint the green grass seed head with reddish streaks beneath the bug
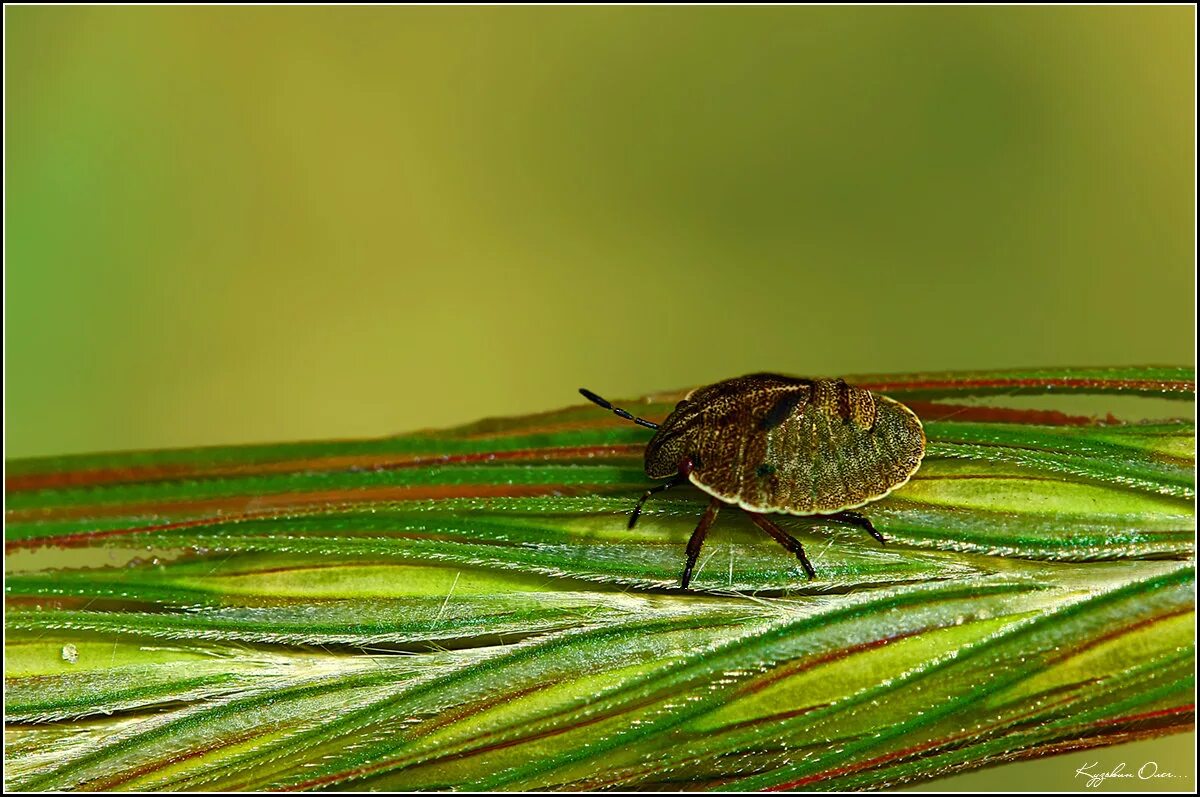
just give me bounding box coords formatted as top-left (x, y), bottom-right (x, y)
top-left (5, 367), bottom-right (1195, 791)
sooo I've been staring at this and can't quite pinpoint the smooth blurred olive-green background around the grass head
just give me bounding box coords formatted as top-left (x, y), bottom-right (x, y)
top-left (5, 6), bottom-right (1195, 790)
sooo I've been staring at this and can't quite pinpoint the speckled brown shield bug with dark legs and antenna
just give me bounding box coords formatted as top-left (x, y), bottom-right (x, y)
top-left (580, 373), bottom-right (925, 589)
